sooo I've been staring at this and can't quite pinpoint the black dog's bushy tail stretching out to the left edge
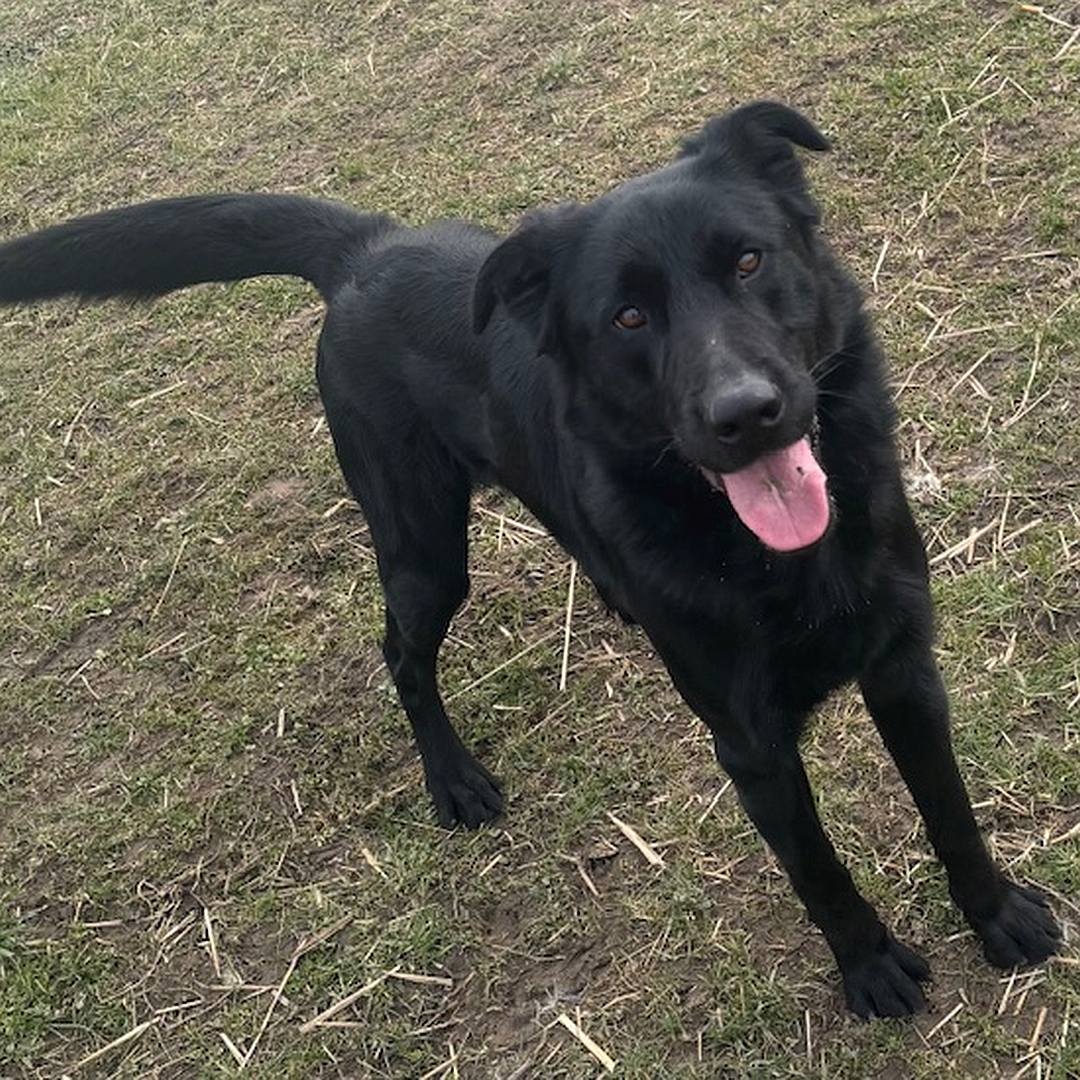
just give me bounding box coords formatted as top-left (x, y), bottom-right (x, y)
top-left (0, 194), bottom-right (395, 303)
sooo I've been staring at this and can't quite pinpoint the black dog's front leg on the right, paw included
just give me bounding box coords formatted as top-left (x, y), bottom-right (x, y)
top-left (860, 642), bottom-right (1061, 968)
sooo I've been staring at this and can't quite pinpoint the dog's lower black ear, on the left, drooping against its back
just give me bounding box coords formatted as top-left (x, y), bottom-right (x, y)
top-left (473, 203), bottom-right (582, 340)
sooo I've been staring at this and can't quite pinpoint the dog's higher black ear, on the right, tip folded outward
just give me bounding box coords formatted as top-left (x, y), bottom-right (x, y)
top-left (679, 102), bottom-right (829, 193)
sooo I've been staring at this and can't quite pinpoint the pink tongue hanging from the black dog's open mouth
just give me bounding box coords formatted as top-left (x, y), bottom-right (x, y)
top-left (720, 438), bottom-right (829, 551)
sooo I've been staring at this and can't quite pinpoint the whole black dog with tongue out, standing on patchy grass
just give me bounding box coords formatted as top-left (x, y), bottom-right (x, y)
top-left (0, 103), bottom-right (1059, 1016)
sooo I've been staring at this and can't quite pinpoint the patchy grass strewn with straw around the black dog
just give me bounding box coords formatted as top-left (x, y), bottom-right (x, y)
top-left (0, 0), bottom-right (1080, 1080)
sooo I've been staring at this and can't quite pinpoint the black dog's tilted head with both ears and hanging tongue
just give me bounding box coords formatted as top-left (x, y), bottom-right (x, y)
top-left (473, 102), bottom-right (839, 550)
